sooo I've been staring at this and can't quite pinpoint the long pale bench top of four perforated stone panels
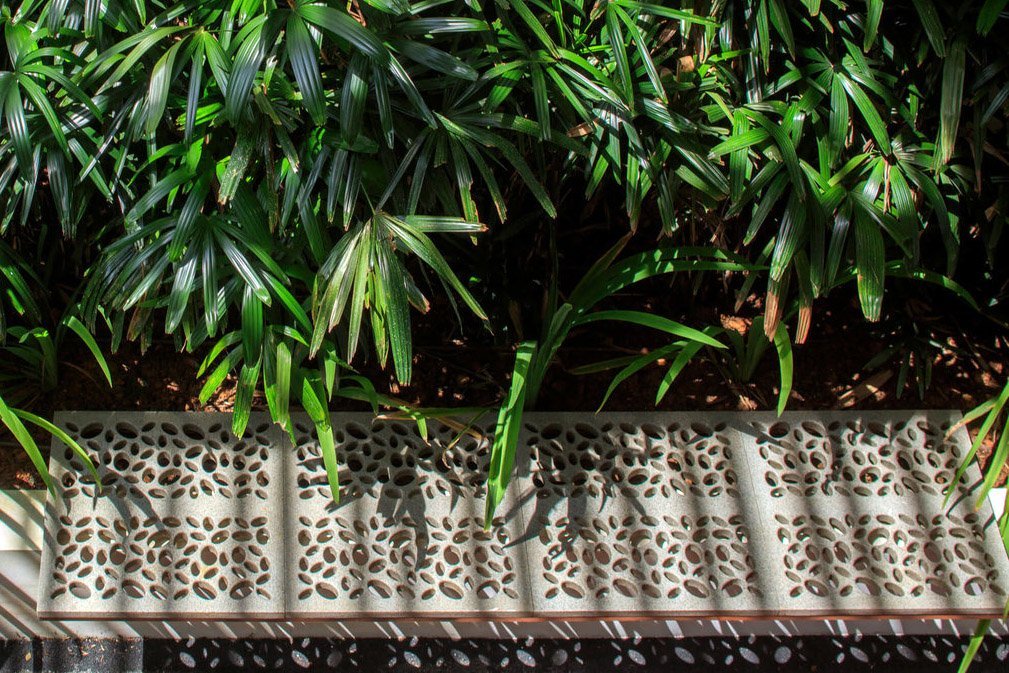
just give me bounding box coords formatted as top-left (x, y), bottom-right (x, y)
top-left (37, 412), bottom-right (1009, 621)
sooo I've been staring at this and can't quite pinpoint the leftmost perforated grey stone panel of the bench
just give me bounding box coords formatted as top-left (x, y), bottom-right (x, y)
top-left (38, 413), bottom-right (286, 619)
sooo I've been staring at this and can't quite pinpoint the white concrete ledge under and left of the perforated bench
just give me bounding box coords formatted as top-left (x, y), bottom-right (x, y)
top-left (0, 489), bottom-right (1009, 641)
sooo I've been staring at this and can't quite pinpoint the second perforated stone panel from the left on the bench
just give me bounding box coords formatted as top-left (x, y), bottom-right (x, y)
top-left (287, 414), bottom-right (532, 619)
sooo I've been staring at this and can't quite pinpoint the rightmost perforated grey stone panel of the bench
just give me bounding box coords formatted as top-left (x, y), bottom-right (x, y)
top-left (741, 412), bottom-right (1009, 614)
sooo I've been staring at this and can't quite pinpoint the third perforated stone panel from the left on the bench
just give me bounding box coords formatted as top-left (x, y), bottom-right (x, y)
top-left (518, 414), bottom-right (770, 616)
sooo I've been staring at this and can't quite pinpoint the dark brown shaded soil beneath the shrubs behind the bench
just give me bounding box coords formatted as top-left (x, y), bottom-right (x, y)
top-left (0, 288), bottom-right (1007, 488)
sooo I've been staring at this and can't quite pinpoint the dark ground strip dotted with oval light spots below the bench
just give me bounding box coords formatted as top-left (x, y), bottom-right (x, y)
top-left (0, 636), bottom-right (1009, 673)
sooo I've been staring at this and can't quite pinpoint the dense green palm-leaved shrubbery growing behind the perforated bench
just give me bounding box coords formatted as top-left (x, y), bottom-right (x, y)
top-left (0, 0), bottom-right (1009, 507)
